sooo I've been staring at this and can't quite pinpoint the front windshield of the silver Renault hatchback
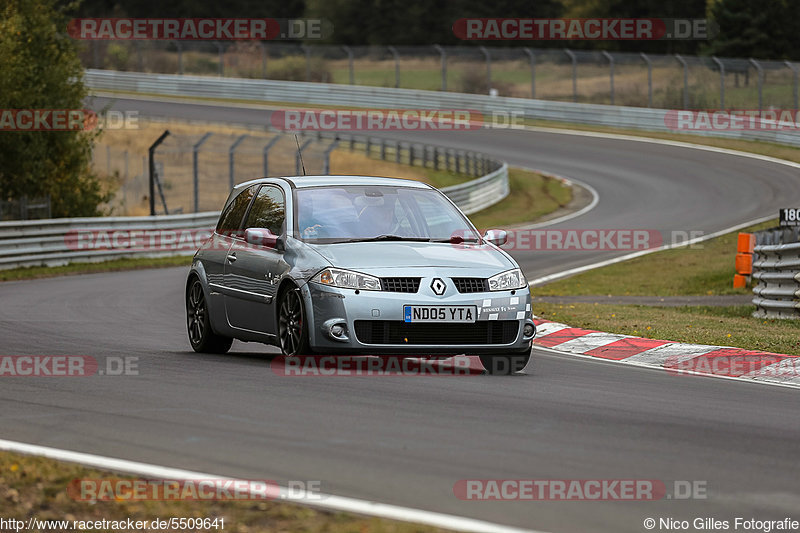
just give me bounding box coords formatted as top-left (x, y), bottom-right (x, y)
top-left (295, 185), bottom-right (479, 244)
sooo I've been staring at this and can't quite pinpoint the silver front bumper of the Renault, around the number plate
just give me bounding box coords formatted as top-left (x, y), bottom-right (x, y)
top-left (301, 278), bottom-right (536, 357)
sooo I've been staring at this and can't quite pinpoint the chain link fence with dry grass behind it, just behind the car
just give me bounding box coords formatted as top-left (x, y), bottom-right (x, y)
top-left (93, 131), bottom-right (502, 215)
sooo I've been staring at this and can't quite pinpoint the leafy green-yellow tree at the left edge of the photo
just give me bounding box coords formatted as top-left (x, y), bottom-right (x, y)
top-left (0, 0), bottom-right (108, 217)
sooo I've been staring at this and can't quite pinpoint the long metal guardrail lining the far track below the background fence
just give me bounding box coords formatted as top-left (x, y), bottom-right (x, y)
top-left (85, 69), bottom-right (800, 146)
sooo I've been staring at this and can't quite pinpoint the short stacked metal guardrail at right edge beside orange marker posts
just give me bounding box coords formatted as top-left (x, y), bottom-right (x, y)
top-left (753, 227), bottom-right (800, 319)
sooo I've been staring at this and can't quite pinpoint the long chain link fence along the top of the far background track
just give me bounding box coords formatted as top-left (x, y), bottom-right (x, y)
top-left (82, 41), bottom-right (800, 109)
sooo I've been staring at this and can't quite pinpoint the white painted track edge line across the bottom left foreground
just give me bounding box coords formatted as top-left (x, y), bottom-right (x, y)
top-left (0, 439), bottom-right (541, 533)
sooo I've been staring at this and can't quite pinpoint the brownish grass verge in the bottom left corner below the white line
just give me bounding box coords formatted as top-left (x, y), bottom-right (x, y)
top-left (0, 452), bottom-right (445, 533)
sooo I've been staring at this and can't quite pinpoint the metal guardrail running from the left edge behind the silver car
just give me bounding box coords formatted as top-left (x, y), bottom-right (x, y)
top-left (0, 164), bottom-right (509, 269)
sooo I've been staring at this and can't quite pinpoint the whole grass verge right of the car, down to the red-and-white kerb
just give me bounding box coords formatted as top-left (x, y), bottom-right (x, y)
top-left (532, 221), bottom-right (800, 355)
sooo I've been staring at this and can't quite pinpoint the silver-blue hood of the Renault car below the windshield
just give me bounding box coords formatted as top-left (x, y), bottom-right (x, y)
top-left (309, 242), bottom-right (516, 271)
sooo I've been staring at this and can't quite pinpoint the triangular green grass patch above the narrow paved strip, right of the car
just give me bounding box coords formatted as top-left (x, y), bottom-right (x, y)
top-left (534, 221), bottom-right (777, 296)
